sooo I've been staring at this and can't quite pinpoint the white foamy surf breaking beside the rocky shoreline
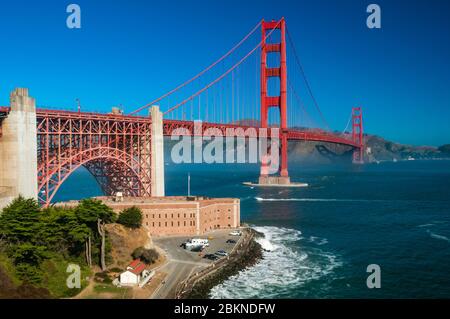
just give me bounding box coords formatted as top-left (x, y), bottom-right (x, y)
top-left (210, 227), bottom-right (342, 299)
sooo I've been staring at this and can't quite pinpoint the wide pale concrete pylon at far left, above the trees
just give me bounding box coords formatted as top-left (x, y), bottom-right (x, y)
top-left (0, 88), bottom-right (38, 208)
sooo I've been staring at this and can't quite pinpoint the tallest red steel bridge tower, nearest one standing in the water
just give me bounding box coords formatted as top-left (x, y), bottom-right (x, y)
top-left (259, 18), bottom-right (290, 184)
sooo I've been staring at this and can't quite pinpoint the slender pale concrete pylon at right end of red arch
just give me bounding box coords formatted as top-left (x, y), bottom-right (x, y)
top-left (150, 105), bottom-right (165, 197)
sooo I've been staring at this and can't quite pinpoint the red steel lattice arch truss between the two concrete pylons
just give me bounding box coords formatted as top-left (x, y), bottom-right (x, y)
top-left (37, 110), bottom-right (151, 205)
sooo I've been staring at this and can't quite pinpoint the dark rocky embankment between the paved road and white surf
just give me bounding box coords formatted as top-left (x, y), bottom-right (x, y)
top-left (178, 228), bottom-right (263, 299)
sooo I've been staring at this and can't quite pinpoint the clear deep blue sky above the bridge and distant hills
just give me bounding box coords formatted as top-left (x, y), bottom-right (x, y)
top-left (0, 0), bottom-right (450, 145)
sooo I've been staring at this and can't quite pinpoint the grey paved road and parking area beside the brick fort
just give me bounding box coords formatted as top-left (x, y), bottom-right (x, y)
top-left (151, 229), bottom-right (243, 299)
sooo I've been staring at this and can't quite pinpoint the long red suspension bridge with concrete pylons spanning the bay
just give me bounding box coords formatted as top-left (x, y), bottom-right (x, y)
top-left (0, 19), bottom-right (364, 205)
